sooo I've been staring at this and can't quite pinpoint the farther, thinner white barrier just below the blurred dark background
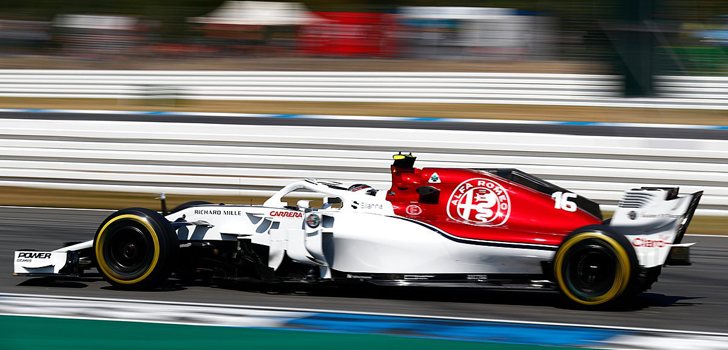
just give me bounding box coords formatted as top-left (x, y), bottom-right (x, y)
top-left (0, 69), bottom-right (728, 109)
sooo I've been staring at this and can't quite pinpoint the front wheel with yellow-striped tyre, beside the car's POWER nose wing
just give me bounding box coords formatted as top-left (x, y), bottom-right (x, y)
top-left (93, 208), bottom-right (179, 289)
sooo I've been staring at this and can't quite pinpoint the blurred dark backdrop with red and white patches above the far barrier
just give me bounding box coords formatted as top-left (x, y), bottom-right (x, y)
top-left (0, 0), bottom-right (728, 80)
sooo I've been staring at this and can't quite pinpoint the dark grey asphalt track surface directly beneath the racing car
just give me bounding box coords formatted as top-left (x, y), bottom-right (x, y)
top-left (0, 207), bottom-right (728, 332)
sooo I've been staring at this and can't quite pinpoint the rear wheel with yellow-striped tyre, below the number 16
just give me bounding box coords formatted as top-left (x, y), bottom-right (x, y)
top-left (553, 226), bottom-right (638, 307)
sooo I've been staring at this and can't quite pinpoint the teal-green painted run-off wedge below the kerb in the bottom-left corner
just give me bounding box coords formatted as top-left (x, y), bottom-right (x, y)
top-left (0, 316), bottom-right (584, 350)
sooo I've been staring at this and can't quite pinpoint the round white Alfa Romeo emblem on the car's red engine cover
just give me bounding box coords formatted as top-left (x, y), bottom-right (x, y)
top-left (447, 179), bottom-right (511, 226)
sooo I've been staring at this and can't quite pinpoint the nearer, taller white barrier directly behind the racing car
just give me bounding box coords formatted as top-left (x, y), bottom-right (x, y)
top-left (0, 118), bottom-right (728, 215)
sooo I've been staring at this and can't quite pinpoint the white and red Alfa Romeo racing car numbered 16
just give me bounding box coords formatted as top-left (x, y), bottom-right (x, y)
top-left (14, 153), bottom-right (702, 306)
